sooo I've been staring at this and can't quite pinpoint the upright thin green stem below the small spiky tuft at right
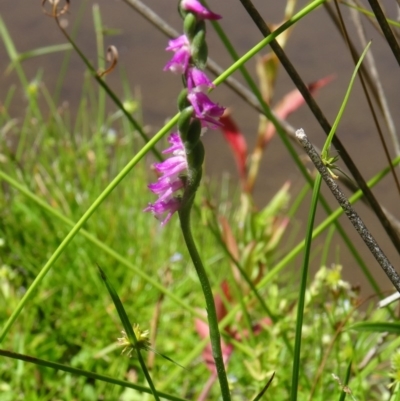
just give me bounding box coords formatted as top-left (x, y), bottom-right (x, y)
top-left (290, 174), bottom-right (322, 401)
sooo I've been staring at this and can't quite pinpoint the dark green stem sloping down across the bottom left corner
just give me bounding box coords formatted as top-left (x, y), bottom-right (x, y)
top-left (0, 349), bottom-right (187, 401)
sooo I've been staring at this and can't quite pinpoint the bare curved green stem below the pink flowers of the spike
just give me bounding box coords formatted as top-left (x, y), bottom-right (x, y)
top-left (179, 206), bottom-right (231, 401)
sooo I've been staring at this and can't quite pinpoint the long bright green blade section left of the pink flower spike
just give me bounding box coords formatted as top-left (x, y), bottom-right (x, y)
top-left (0, 115), bottom-right (178, 343)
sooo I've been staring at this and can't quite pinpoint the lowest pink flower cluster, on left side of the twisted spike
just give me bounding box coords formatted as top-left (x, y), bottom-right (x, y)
top-left (144, 133), bottom-right (188, 226)
